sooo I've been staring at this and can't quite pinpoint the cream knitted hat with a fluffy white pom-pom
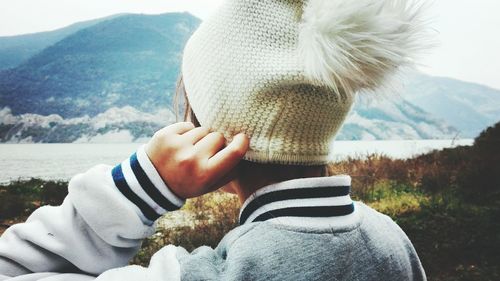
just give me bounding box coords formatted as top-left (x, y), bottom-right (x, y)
top-left (182, 0), bottom-right (430, 165)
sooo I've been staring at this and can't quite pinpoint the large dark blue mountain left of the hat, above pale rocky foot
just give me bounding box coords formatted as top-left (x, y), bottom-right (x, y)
top-left (0, 13), bottom-right (199, 118)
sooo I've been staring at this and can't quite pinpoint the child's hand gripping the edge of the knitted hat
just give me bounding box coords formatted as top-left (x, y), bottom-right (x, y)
top-left (145, 122), bottom-right (248, 198)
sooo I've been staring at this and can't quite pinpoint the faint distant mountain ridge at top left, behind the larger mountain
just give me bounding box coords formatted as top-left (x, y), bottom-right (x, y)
top-left (0, 15), bottom-right (120, 71)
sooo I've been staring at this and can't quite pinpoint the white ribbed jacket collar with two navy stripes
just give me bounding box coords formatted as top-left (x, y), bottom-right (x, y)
top-left (239, 175), bottom-right (354, 225)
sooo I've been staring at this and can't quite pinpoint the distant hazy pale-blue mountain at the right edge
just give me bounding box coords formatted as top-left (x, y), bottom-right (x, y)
top-left (402, 73), bottom-right (500, 138)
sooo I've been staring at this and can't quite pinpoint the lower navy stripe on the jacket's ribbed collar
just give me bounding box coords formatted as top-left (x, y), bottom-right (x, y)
top-left (246, 204), bottom-right (354, 224)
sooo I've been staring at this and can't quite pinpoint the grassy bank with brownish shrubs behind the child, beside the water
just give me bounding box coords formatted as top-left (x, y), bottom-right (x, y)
top-left (0, 124), bottom-right (500, 280)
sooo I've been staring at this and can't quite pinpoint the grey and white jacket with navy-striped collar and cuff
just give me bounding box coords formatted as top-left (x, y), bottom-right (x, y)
top-left (0, 145), bottom-right (426, 281)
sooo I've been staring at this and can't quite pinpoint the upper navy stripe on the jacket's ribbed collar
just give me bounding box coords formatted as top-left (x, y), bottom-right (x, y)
top-left (240, 186), bottom-right (351, 224)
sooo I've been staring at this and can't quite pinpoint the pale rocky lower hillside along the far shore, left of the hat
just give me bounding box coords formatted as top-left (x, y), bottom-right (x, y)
top-left (0, 106), bottom-right (175, 143)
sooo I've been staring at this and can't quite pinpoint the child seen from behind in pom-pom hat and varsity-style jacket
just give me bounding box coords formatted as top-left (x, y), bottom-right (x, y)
top-left (0, 0), bottom-right (425, 281)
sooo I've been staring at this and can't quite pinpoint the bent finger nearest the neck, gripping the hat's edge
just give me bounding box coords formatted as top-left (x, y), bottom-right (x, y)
top-left (207, 134), bottom-right (249, 181)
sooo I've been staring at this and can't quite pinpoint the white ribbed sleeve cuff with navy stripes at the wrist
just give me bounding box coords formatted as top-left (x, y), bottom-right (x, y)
top-left (111, 145), bottom-right (185, 224)
